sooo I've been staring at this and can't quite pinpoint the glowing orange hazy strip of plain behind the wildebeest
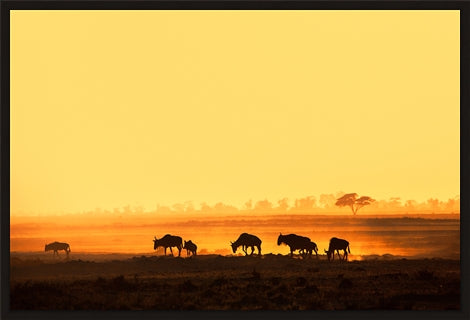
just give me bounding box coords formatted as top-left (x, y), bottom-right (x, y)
top-left (10, 214), bottom-right (460, 257)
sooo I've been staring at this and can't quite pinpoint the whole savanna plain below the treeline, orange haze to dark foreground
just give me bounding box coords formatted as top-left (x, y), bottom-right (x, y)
top-left (10, 215), bottom-right (460, 310)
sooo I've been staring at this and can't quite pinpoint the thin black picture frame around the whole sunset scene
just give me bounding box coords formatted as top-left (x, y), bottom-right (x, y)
top-left (0, 0), bottom-right (470, 320)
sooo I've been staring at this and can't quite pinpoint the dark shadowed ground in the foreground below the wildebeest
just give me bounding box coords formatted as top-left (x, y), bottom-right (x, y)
top-left (10, 254), bottom-right (460, 310)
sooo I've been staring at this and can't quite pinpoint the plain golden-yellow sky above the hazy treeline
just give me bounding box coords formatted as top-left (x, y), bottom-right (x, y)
top-left (10, 10), bottom-right (460, 214)
